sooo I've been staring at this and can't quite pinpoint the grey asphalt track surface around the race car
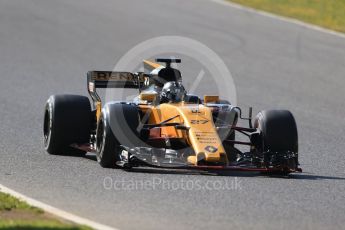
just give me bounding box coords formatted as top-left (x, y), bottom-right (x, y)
top-left (0, 0), bottom-right (345, 229)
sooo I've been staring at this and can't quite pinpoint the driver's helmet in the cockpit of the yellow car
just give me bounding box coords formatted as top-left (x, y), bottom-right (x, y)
top-left (160, 81), bottom-right (187, 103)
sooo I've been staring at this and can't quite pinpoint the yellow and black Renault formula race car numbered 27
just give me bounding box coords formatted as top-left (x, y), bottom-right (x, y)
top-left (43, 58), bottom-right (301, 174)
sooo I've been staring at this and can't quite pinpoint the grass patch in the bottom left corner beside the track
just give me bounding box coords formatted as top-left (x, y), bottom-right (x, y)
top-left (0, 192), bottom-right (90, 230)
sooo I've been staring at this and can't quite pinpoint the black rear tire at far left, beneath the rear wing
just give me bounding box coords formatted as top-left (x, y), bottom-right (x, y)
top-left (43, 95), bottom-right (91, 155)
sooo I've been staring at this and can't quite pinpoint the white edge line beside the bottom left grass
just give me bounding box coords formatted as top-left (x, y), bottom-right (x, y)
top-left (0, 184), bottom-right (118, 230)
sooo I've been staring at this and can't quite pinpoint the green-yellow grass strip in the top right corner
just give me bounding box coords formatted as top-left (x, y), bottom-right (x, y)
top-left (230, 0), bottom-right (345, 32)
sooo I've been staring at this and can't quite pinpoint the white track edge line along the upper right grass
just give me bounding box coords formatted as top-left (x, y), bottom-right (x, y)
top-left (211, 0), bottom-right (345, 38)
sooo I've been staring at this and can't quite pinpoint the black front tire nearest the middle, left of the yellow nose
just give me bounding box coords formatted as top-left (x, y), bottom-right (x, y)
top-left (96, 104), bottom-right (139, 168)
